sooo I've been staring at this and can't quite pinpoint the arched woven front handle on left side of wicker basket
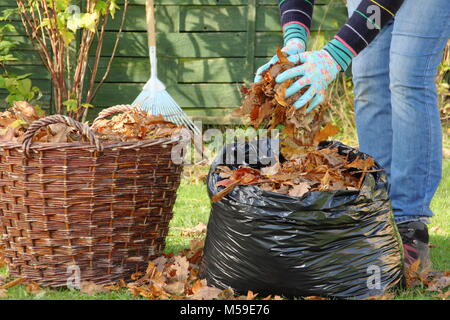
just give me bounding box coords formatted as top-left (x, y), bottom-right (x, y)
top-left (22, 114), bottom-right (103, 157)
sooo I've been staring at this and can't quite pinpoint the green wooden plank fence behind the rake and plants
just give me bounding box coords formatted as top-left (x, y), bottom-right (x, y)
top-left (0, 0), bottom-right (347, 124)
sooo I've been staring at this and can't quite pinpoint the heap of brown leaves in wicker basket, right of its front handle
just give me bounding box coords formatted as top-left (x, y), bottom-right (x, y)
top-left (92, 109), bottom-right (181, 141)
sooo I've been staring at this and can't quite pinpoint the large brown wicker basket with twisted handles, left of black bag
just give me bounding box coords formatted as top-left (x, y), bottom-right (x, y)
top-left (0, 106), bottom-right (184, 287)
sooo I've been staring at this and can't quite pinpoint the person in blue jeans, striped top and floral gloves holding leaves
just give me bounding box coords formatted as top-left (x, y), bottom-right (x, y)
top-left (255, 0), bottom-right (450, 269)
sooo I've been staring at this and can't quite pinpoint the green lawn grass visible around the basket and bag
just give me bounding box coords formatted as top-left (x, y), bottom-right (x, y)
top-left (0, 160), bottom-right (450, 300)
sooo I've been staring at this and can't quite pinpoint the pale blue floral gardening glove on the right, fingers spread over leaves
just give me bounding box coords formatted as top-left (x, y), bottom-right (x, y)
top-left (275, 39), bottom-right (353, 113)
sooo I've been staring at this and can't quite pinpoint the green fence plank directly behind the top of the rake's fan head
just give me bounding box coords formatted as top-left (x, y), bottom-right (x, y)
top-left (93, 83), bottom-right (241, 108)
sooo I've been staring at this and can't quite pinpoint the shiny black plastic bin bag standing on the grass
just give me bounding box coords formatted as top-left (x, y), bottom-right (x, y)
top-left (200, 140), bottom-right (403, 299)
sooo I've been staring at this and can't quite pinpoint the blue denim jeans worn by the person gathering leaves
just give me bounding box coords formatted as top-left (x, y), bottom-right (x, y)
top-left (348, 0), bottom-right (450, 223)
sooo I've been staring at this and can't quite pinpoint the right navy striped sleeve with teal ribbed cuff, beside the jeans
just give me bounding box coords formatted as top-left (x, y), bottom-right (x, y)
top-left (324, 0), bottom-right (404, 71)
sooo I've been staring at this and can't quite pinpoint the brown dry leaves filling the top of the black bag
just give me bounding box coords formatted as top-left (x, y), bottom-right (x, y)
top-left (212, 148), bottom-right (376, 202)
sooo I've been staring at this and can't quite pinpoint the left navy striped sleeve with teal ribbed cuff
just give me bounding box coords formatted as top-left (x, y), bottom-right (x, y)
top-left (278, 0), bottom-right (314, 47)
